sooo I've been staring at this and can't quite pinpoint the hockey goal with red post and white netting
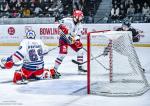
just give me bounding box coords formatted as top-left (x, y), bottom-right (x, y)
top-left (87, 31), bottom-right (149, 96)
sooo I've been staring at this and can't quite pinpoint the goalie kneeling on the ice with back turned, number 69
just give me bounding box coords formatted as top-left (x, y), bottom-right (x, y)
top-left (2, 30), bottom-right (59, 84)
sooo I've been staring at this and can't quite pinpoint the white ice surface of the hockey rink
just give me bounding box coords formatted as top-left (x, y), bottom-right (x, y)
top-left (0, 46), bottom-right (150, 106)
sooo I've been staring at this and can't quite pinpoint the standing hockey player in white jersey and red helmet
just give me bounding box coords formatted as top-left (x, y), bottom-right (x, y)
top-left (51, 10), bottom-right (87, 72)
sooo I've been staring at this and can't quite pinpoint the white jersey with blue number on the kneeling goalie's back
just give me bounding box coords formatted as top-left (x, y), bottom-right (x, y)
top-left (13, 39), bottom-right (48, 70)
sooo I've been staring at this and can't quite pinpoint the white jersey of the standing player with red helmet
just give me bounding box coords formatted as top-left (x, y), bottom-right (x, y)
top-left (59, 18), bottom-right (83, 39)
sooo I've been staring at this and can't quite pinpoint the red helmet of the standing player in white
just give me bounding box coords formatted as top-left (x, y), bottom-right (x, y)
top-left (73, 10), bottom-right (83, 22)
